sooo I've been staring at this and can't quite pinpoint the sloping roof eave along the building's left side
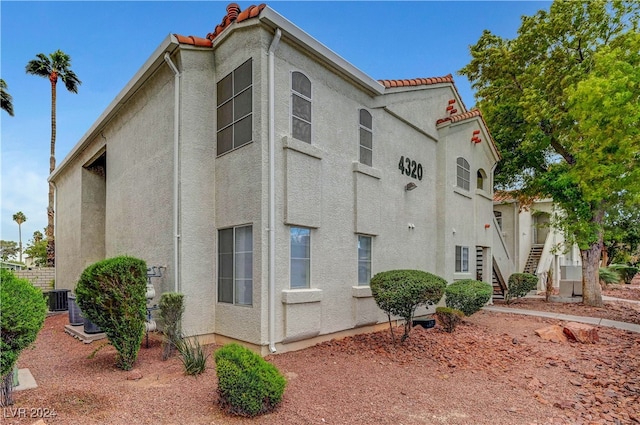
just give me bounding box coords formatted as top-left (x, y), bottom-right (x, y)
top-left (47, 34), bottom-right (180, 182)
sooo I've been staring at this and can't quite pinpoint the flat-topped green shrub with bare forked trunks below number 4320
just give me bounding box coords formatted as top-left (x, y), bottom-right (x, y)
top-left (371, 270), bottom-right (447, 344)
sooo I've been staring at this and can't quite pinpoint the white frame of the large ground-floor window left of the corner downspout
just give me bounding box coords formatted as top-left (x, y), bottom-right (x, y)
top-left (217, 224), bottom-right (253, 307)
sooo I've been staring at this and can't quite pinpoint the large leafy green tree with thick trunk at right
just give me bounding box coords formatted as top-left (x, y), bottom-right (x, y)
top-left (459, 0), bottom-right (640, 306)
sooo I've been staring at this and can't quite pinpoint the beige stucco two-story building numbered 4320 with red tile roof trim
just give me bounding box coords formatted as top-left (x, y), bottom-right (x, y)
top-left (50, 5), bottom-right (499, 353)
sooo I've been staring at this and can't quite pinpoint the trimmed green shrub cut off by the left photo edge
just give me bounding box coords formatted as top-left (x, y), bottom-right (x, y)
top-left (0, 269), bottom-right (47, 406)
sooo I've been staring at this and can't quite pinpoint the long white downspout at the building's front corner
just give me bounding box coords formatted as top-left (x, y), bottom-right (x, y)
top-left (269, 28), bottom-right (282, 353)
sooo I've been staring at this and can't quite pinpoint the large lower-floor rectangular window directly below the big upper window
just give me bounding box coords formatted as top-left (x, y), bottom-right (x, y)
top-left (218, 226), bottom-right (253, 305)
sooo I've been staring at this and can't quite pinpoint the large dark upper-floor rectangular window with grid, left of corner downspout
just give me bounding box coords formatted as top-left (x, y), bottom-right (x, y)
top-left (216, 59), bottom-right (253, 155)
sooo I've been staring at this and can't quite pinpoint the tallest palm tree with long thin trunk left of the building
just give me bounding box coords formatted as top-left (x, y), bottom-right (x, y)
top-left (26, 50), bottom-right (82, 267)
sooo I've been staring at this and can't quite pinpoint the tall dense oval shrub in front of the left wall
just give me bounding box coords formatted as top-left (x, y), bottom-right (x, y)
top-left (76, 256), bottom-right (147, 370)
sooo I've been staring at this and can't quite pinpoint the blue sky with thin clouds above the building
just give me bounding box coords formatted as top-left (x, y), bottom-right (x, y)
top-left (0, 0), bottom-right (550, 245)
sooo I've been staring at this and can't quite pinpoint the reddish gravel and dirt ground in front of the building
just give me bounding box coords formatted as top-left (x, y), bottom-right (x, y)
top-left (8, 282), bottom-right (640, 425)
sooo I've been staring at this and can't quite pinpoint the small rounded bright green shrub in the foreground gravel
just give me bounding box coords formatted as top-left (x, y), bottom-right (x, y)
top-left (215, 344), bottom-right (287, 417)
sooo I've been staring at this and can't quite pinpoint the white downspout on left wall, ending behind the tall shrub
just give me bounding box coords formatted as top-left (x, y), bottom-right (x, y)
top-left (164, 52), bottom-right (182, 292)
